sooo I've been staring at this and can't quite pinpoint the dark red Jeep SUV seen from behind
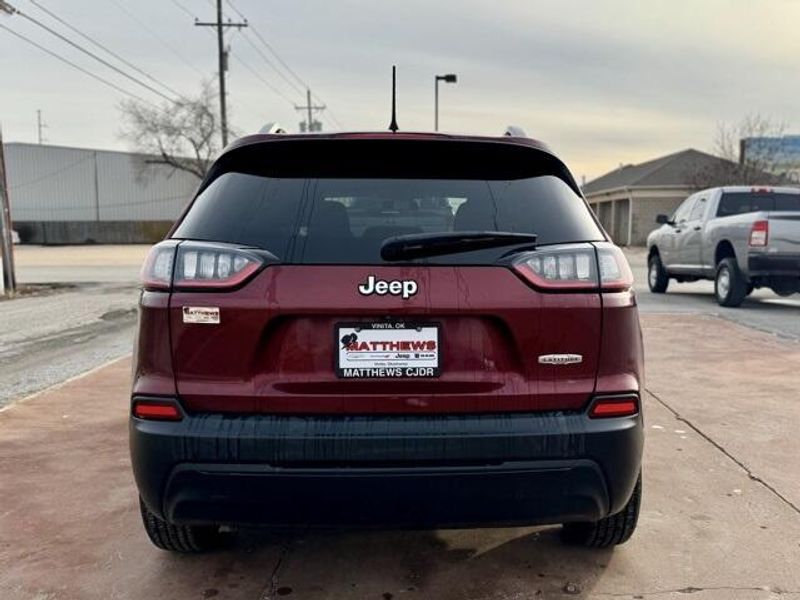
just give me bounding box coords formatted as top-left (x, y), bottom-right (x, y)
top-left (130, 133), bottom-right (643, 552)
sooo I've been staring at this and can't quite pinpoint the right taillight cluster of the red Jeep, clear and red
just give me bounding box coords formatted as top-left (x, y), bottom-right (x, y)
top-left (513, 244), bottom-right (633, 291)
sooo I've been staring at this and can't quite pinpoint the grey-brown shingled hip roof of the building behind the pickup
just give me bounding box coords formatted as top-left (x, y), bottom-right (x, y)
top-left (583, 148), bottom-right (737, 196)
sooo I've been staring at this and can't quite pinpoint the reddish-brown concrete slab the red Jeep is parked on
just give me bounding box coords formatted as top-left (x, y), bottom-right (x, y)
top-left (0, 315), bottom-right (800, 600)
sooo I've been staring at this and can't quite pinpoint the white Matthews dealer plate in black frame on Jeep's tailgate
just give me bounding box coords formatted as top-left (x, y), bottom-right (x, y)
top-left (336, 322), bottom-right (440, 379)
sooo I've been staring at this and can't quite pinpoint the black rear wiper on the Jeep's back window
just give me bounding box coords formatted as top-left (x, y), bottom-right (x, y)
top-left (381, 231), bottom-right (536, 262)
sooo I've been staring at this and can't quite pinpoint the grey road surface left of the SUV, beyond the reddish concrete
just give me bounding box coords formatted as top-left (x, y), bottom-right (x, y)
top-left (0, 246), bottom-right (144, 407)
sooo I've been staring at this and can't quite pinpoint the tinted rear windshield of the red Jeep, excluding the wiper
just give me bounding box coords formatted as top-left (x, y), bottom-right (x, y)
top-left (173, 172), bottom-right (603, 264)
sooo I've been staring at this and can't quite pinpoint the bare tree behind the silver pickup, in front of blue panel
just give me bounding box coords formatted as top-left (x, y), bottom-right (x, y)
top-left (690, 114), bottom-right (790, 188)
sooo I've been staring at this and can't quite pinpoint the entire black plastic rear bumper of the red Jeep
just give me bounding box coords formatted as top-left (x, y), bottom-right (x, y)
top-left (130, 404), bottom-right (643, 527)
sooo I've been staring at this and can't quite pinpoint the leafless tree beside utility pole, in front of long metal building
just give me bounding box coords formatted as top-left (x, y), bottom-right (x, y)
top-left (120, 82), bottom-right (221, 179)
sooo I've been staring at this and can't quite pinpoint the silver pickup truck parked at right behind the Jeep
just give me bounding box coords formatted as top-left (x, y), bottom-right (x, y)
top-left (647, 186), bottom-right (800, 306)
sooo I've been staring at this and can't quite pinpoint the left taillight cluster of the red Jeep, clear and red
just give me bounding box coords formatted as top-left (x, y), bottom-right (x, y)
top-left (142, 241), bottom-right (264, 290)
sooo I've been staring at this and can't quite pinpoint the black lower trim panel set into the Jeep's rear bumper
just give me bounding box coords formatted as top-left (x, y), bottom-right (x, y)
top-left (164, 460), bottom-right (609, 527)
